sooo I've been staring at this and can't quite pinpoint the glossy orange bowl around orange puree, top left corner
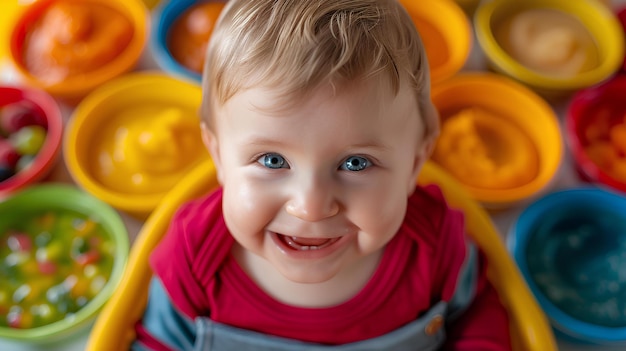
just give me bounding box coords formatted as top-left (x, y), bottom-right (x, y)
top-left (10, 0), bottom-right (149, 102)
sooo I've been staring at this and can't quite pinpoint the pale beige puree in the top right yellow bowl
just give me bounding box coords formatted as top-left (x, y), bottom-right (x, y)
top-left (494, 9), bottom-right (599, 77)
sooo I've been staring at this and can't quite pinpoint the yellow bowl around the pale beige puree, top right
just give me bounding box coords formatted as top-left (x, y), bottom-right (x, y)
top-left (474, 0), bottom-right (624, 96)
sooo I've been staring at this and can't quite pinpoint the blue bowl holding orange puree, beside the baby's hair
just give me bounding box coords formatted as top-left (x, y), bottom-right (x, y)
top-left (149, 0), bottom-right (202, 84)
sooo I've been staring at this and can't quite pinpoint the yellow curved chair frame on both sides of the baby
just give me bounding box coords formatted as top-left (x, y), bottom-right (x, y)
top-left (87, 161), bottom-right (557, 351)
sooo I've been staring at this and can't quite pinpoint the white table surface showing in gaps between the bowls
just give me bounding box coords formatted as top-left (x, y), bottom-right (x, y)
top-left (0, 0), bottom-right (626, 351)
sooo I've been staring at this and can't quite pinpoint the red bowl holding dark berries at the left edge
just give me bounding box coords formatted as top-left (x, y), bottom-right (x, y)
top-left (0, 86), bottom-right (63, 199)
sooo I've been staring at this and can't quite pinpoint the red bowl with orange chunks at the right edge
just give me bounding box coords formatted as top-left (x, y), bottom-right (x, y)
top-left (565, 75), bottom-right (626, 192)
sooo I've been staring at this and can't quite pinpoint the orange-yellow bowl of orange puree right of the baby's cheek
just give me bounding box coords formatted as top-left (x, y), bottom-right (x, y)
top-left (432, 73), bottom-right (563, 208)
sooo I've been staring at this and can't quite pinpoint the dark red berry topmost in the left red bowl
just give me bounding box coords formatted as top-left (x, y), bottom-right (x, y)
top-left (0, 100), bottom-right (48, 134)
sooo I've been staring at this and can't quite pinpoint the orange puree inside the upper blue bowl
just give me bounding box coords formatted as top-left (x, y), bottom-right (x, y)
top-left (168, 2), bottom-right (224, 73)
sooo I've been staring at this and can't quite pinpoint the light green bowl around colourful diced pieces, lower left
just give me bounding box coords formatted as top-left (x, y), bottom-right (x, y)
top-left (0, 183), bottom-right (129, 344)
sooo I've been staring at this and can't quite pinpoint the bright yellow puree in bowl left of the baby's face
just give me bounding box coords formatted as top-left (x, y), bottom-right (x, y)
top-left (92, 106), bottom-right (208, 194)
